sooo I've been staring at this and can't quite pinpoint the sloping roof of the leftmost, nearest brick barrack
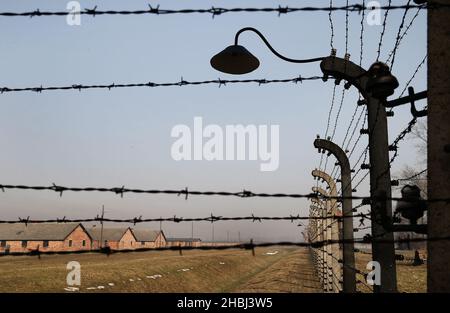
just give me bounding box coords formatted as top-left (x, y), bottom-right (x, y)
top-left (0, 223), bottom-right (84, 241)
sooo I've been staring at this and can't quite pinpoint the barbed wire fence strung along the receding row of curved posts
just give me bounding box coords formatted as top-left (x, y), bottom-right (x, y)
top-left (308, 0), bottom-right (427, 292)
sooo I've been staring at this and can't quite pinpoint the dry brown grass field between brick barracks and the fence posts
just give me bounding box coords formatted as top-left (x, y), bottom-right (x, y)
top-left (0, 247), bottom-right (320, 292)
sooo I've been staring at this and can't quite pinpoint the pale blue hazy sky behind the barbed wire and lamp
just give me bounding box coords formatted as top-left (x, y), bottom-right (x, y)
top-left (0, 0), bottom-right (426, 240)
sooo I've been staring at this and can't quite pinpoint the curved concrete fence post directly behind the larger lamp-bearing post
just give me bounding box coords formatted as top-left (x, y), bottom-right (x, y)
top-left (314, 139), bottom-right (356, 292)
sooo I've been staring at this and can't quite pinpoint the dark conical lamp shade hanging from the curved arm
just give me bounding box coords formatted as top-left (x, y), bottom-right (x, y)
top-left (210, 45), bottom-right (259, 75)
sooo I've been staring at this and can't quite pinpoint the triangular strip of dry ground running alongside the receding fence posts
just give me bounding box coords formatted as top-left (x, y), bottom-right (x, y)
top-left (232, 249), bottom-right (322, 293)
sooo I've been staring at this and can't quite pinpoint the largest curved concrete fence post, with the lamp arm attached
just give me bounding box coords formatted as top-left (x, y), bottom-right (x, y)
top-left (320, 56), bottom-right (397, 292)
